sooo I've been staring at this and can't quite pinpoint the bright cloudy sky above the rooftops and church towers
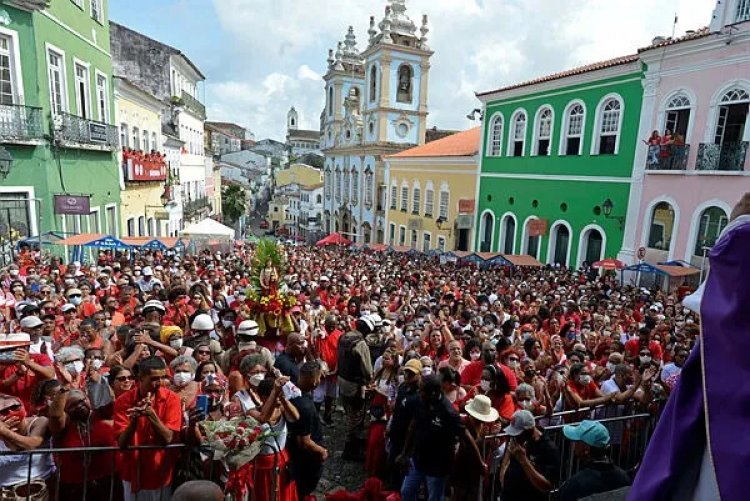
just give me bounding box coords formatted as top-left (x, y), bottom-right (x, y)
top-left (110, 0), bottom-right (715, 139)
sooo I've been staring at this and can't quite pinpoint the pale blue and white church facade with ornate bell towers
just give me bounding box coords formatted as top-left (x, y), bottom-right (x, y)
top-left (321, 0), bottom-right (433, 243)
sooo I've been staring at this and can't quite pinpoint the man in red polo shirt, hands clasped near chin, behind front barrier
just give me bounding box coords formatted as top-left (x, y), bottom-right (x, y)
top-left (113, 357), bottom-right (182, 499)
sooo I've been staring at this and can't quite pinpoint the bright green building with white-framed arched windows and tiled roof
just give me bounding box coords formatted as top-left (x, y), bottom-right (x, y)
top-left (475, 55), bottom-right (643, 267)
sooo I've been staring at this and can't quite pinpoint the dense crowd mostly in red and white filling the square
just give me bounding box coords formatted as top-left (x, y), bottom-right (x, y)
top-left (0, 239), bottom-right (699, 501)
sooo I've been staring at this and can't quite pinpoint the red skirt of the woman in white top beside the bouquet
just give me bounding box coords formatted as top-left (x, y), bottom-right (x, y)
top-left (226, 449), bottom-right (297, 501)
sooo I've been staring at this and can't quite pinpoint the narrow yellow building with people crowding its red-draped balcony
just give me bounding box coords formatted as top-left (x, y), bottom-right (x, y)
top-left (114, 77), bottom-right (171, 236)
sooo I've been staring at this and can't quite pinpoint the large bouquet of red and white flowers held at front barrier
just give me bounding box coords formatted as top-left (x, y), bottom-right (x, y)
top-left (201, 416), bottom-right (274, 470)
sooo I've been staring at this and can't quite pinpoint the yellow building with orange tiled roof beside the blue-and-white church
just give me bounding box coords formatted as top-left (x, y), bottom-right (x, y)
top-left (385, 127), bottom-right (480, 252)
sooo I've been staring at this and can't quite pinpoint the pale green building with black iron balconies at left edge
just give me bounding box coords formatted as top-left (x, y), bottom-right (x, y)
top-left (0, 0), bottom-right (121, 258)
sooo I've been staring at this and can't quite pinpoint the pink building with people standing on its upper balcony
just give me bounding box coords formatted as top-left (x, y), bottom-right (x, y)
top-left (620, 0), bottom-right (750, 267)
